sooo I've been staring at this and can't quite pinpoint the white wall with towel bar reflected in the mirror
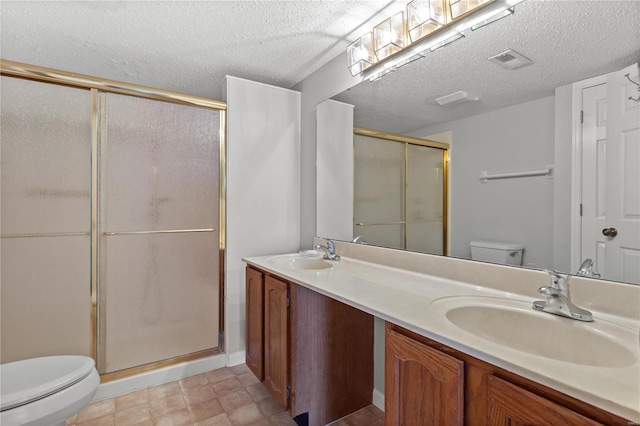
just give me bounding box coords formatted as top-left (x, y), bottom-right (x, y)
top-left (411, 96), bottom-right (555, 268)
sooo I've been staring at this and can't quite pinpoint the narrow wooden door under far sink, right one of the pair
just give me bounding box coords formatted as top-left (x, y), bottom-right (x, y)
top-left (264, 275), bottom-right (289, 408)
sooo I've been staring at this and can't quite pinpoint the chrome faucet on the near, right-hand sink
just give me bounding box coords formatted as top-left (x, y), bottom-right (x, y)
top-left (533, 270), bottom-right (593, 321)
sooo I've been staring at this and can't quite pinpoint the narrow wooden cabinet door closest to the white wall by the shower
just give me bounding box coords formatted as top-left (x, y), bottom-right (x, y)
top-left (245, 268), bottom-right (264, 381)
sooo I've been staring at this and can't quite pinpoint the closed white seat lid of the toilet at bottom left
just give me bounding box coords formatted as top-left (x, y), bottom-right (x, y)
top-left (0, 355), bottom-right (95, 411)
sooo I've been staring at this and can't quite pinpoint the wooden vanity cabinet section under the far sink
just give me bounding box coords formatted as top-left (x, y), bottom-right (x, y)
top-left (245, 266), bottom-right (373, 426)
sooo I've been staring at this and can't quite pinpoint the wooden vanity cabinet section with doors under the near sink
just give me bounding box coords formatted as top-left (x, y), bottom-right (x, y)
top-left (385, 323), bottom-right (631, 426)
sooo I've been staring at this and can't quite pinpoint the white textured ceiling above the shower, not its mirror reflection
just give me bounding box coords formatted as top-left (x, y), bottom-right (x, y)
top-left (0, 0), bottom-right (393, 99)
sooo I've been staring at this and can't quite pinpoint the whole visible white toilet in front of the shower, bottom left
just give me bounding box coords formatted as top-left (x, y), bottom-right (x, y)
top-left (0, 355), bottom-right (100, 426)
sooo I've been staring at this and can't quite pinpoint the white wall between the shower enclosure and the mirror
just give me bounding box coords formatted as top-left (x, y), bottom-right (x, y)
top-left (225, 77), bottom-right (302, 365)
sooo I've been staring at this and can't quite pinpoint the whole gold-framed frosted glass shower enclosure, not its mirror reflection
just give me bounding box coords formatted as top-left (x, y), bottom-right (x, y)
top-left (0, 61), bottom-right (225, 380)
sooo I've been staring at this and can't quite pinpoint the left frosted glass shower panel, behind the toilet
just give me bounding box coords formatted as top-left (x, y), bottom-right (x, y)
top-left (0, 77), bottom-right (91, 363)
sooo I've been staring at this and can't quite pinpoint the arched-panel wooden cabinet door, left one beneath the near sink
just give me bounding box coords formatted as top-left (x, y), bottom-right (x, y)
top-left (385, 327), bottom-right (464, 426)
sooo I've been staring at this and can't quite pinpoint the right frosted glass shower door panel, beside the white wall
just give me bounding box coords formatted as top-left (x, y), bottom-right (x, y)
top-left (98, 94), bottom-right (220, 373)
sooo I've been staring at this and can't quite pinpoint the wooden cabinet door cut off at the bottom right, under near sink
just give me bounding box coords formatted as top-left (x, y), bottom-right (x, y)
top-left (487, 376), bottom-right (601, 426)
